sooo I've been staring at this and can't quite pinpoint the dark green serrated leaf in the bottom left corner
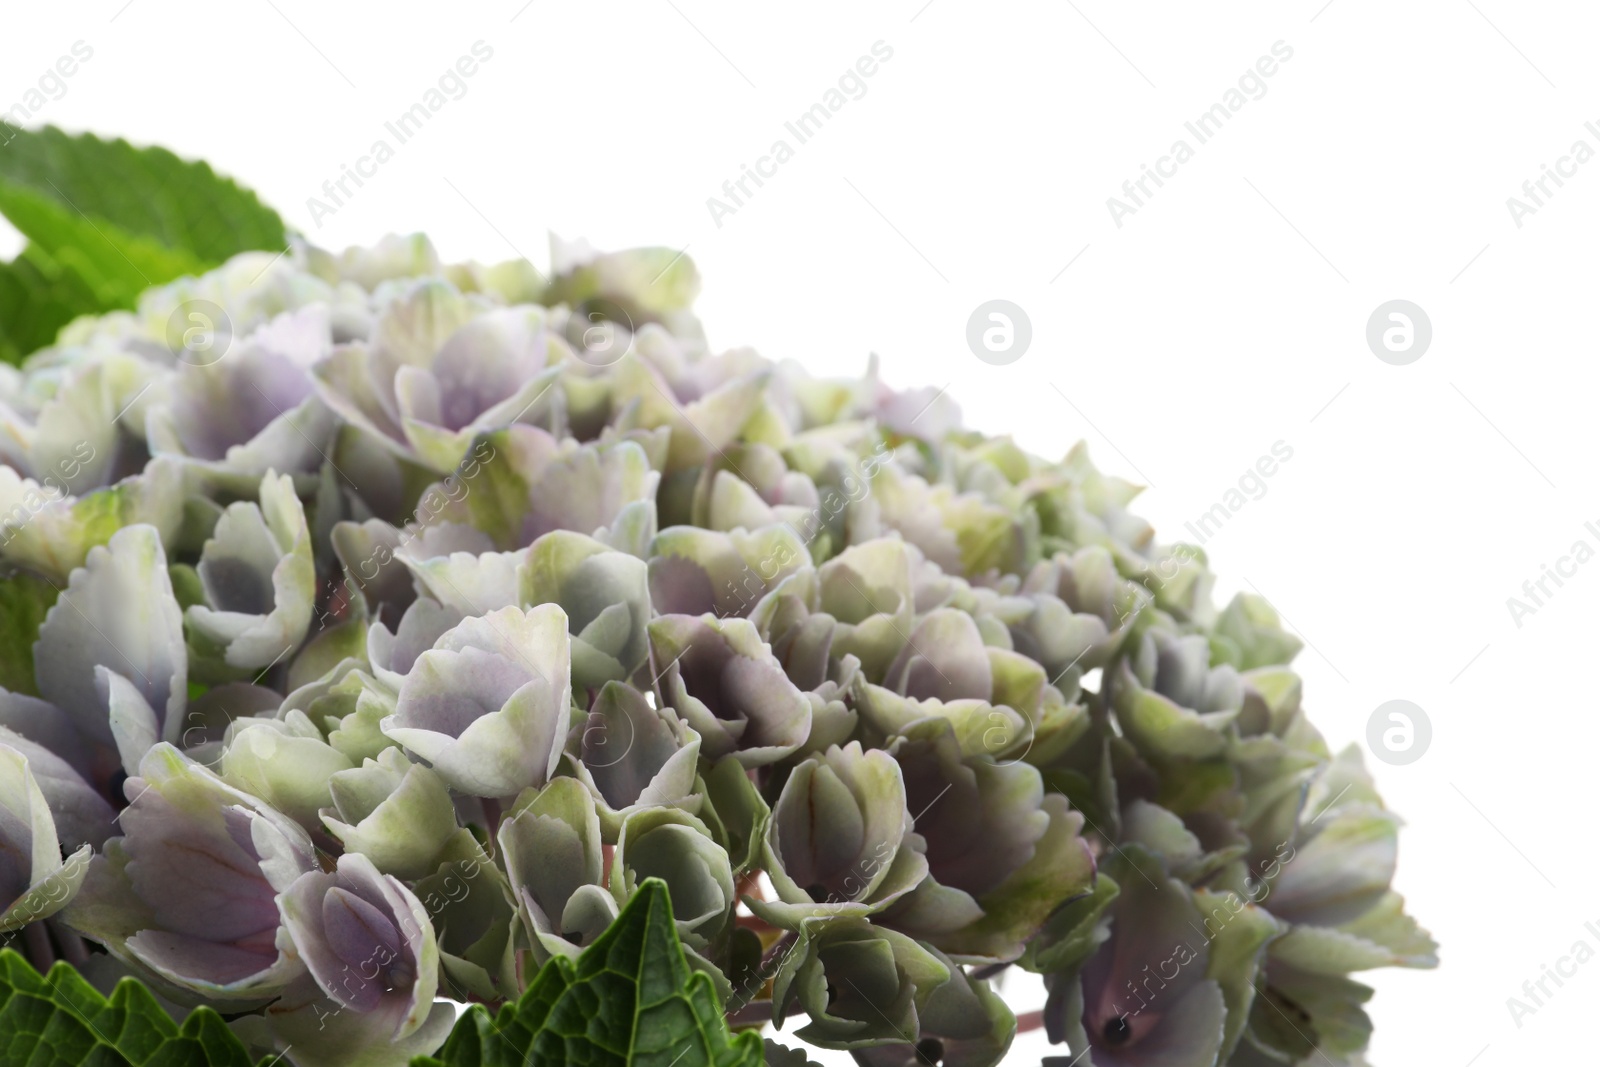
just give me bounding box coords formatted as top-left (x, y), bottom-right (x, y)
top-left (0, 949), bottom-right (262, 1067)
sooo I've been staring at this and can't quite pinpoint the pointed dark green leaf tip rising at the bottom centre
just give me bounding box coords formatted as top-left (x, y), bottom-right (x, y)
top-left (411, 878), bottom-right (763, 1067)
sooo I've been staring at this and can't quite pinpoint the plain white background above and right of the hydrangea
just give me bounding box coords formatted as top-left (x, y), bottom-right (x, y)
top-left (0, 0), bottom-right (1600, 1067)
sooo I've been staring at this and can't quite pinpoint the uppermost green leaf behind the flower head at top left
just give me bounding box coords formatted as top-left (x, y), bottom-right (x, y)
top-left (0, 126), bottom-right (288, 262)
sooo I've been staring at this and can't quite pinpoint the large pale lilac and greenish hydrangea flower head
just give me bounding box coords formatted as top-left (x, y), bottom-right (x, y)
top-left (0, 238), bottom-right (1434, 1067)
